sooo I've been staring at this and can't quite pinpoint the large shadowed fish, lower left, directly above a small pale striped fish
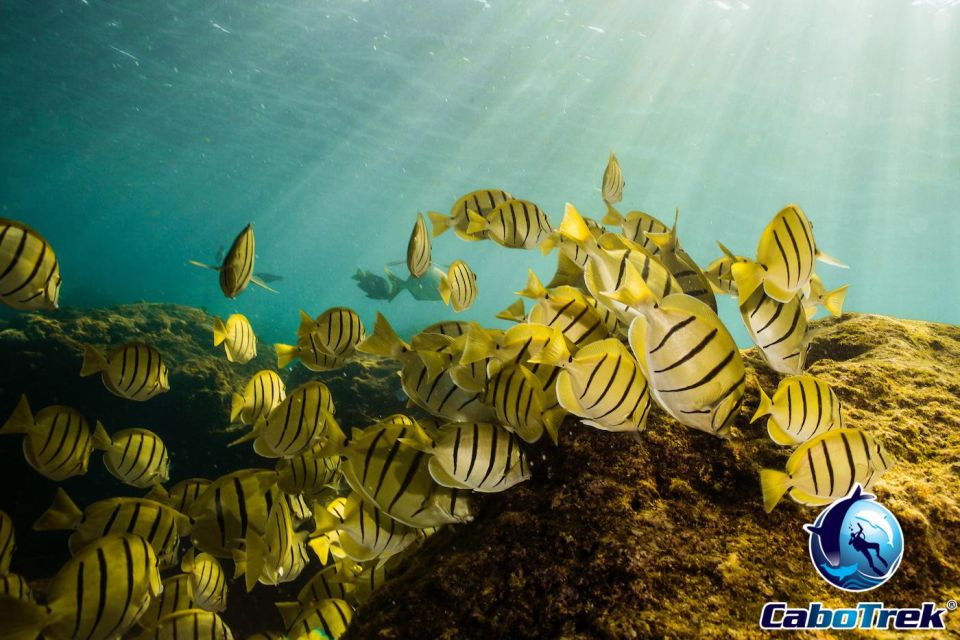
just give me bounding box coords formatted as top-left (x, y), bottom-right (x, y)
top-left (187, 469), bottom-right (277, 558)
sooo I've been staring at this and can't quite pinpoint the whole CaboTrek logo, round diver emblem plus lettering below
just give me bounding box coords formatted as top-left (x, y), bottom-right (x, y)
top-left (760, 485), bottom-right (957, 630)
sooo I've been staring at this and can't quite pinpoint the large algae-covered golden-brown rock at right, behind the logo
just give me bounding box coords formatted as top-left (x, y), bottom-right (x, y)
top-left (348, 314), bottom-right (960, 639)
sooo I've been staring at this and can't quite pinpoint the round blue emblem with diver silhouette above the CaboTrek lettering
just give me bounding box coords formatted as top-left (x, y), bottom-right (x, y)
top-left (803, 484), bottom-right (903, 592)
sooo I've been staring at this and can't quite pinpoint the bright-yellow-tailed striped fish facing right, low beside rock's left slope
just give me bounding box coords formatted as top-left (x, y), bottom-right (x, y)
top-left (316, 492), bottom-right (420, 562)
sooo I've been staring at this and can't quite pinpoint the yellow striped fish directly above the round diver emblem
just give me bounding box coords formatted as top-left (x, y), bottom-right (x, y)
top-left (760, 429), bottom-right (895, 513)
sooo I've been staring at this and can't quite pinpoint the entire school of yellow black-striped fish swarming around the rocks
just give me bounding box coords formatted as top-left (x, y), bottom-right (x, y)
top-left (0, 153), bottom-right (894, 640)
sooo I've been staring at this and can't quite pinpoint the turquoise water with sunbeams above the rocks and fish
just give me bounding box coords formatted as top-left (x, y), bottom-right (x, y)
top-left (0, 0), bottom-right (960, 341)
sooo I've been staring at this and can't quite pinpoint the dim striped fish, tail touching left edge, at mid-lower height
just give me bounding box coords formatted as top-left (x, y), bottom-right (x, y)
top-left (0, 395), bottom-right (93, 482)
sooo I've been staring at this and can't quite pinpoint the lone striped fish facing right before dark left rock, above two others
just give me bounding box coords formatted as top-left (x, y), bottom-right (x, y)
top-left (80, 342), bottom-right (170, 402)
